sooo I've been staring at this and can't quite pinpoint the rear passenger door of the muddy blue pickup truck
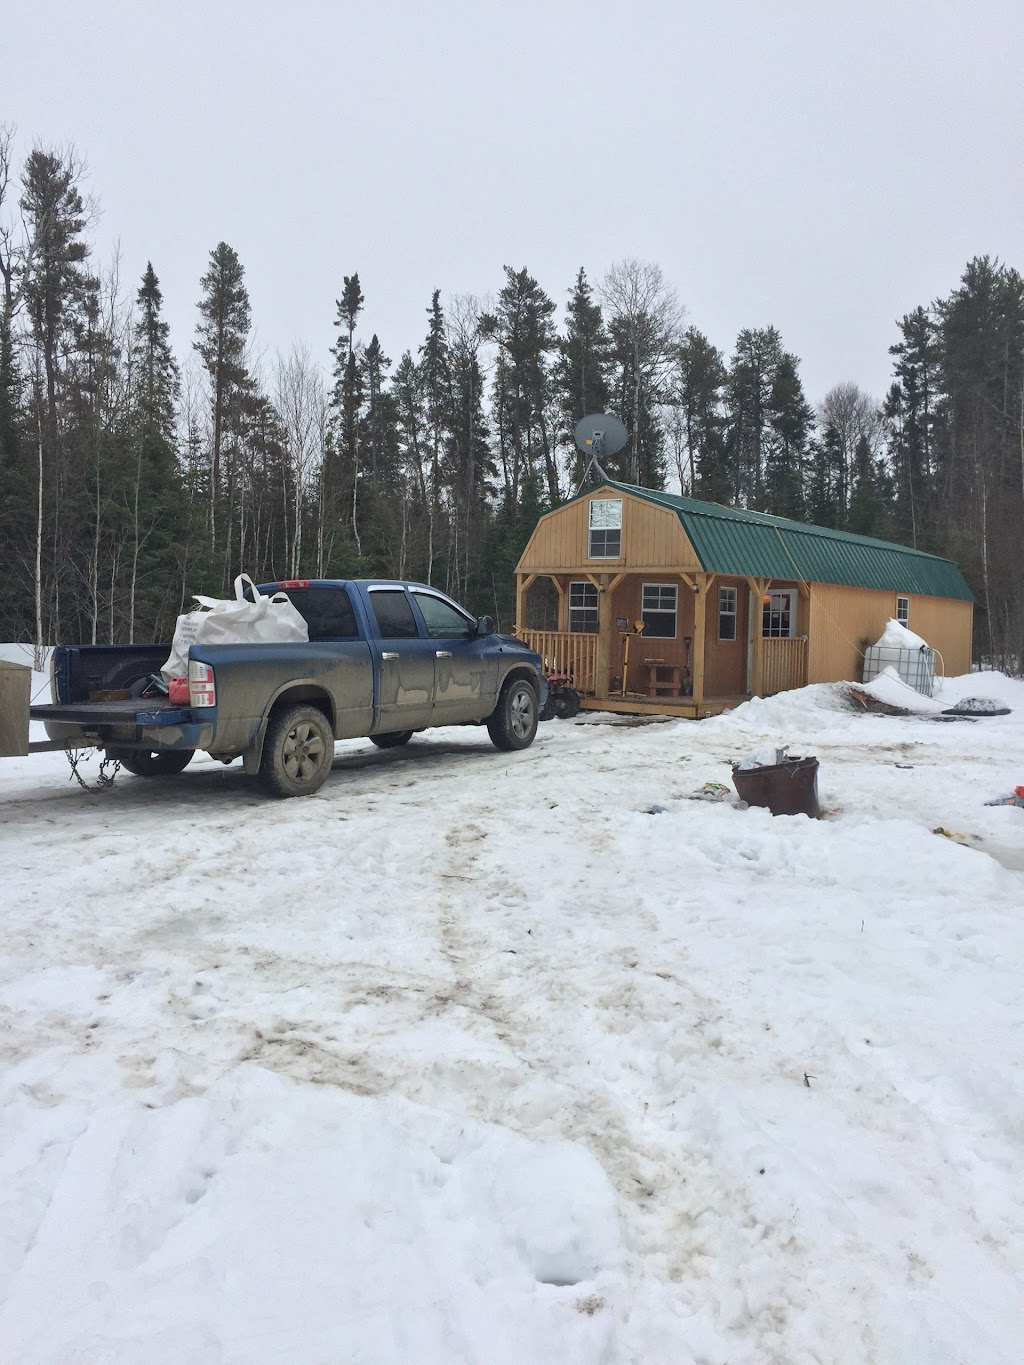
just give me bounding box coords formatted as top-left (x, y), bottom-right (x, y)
top-left (367, 587), bottom-right (434, 733)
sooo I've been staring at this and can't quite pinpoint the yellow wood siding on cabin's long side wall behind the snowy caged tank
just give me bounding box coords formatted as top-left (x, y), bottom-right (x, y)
top-left (807, 583), bottom-right (973, 683)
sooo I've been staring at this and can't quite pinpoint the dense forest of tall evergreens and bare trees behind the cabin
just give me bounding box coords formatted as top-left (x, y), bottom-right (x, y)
top-left (0, 128), bottom-right (1024, 673)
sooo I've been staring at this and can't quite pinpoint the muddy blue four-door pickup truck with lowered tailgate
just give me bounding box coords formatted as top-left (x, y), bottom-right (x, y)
top-left (30, 579), bottom-right (547, 797)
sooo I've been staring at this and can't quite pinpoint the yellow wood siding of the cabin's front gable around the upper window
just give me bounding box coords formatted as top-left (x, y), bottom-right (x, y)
top-left (517, 489), bottom-right (700, 573)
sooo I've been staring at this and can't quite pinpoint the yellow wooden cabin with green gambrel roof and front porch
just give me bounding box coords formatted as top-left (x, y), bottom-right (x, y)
top-left (515, 479), bottom-right (973, 718)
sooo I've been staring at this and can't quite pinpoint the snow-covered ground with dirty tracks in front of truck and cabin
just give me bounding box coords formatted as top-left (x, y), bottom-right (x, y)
top-left (0, 663), bottom-right (1024, 1365)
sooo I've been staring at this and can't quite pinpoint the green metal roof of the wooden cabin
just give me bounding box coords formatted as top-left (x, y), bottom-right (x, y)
top-left (578, 479), bottom-right (973, 602)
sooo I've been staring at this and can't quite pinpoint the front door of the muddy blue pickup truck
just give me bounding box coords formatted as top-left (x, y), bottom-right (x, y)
top-left (410, 588), bottom-right (498, 725)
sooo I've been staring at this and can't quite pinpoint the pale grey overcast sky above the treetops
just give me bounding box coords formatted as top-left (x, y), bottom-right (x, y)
top-left (8, 0), bottom-right (1024, 401)
